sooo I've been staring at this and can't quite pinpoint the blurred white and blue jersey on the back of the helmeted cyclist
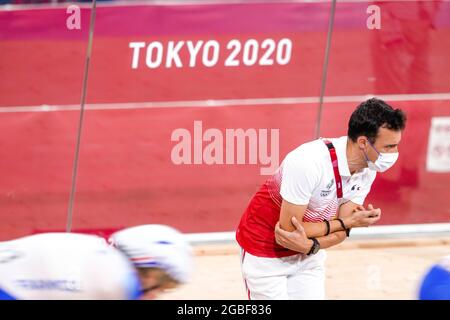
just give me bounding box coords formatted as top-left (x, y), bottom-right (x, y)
top-left (0, 233), bottom-right (140, 300)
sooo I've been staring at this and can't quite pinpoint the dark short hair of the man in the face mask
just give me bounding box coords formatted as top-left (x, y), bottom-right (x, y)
top-left (347, 98), bottom-right (406, 143)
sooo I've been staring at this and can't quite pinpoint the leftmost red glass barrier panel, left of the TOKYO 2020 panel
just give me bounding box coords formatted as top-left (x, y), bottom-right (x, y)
top-left (0, 4), bottom-right (89, 241)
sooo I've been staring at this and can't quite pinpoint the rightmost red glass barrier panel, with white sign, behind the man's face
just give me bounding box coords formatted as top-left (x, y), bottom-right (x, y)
top-left (321, 1), bottom-right (450, 224)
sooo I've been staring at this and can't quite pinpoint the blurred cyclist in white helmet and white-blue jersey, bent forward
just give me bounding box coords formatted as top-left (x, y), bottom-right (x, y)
top-left (0, 225), bottom-right (192, 300)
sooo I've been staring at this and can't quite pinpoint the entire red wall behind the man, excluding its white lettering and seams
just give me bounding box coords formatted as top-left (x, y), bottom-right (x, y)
top-left (0, 1), bottom-right (450, 240)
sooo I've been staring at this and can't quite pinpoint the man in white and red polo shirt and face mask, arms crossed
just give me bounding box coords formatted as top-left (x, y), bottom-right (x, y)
top-left (236, 98), bottom-right (406, 299)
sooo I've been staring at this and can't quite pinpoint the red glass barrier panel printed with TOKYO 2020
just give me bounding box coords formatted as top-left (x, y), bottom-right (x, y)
top-left (74, 2), bottom-right (330, 233)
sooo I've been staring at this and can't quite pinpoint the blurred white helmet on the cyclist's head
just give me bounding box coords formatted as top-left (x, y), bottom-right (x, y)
top-left (109, 224), bottom-right (192, 283)
